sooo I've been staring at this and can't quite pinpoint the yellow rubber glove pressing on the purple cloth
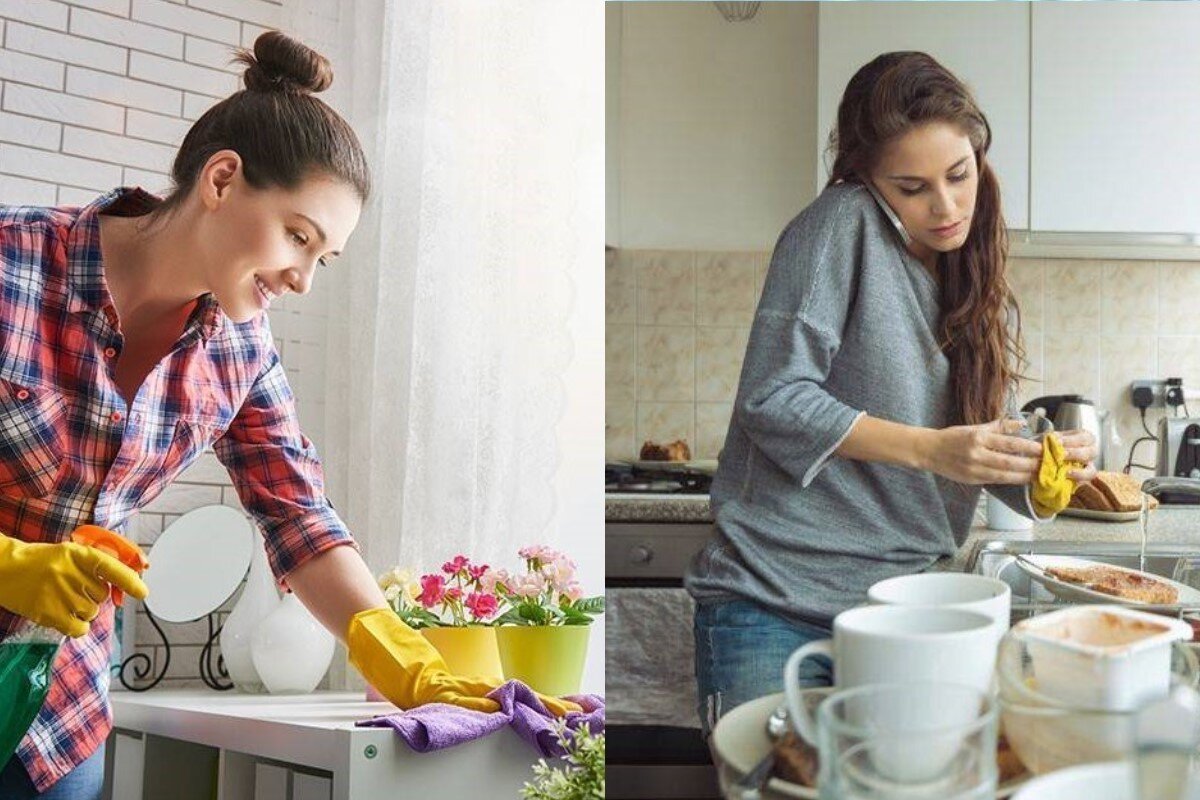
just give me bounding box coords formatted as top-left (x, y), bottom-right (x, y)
top-left (346, 608), bottom-right (582, 716)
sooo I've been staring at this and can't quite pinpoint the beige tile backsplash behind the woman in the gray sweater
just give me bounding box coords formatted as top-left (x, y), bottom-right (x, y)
top-left (605, 249), bottom-right (1200, 469)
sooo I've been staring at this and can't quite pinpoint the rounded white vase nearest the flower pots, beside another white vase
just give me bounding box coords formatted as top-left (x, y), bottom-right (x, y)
top-left (251, 594), bottom-right (334, 694)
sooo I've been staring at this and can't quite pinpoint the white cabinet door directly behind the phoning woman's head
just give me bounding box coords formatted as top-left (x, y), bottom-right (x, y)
top-left (816, 2), bottom-right (1032, 228)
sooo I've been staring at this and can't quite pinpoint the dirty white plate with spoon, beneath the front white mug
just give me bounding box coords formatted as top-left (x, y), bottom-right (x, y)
top-left (710, 688), bottom-right (1027, 800)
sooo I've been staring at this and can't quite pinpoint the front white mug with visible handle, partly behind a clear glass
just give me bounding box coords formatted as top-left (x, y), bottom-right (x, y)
top-left (784, 606), bottom-right (996, 747)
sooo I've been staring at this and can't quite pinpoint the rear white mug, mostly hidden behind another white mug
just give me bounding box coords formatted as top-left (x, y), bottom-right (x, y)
top-left (866, 572), bottom-right (1013, 645)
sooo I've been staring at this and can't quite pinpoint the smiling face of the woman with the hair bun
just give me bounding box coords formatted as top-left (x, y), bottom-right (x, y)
top-left (200, 154), bottom-right (362, 323)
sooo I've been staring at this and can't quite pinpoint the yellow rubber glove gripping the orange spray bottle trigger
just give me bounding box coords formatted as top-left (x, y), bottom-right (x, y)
top-left (0, 534), bottom-right (148, 637)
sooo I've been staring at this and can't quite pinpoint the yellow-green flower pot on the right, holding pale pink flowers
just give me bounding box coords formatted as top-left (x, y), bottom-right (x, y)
top-left (496, 625), bottom-right (592, 697)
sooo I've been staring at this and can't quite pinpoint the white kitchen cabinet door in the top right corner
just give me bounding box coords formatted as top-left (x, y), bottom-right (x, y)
top-left (1031, 2), bottom-right (1200, 234)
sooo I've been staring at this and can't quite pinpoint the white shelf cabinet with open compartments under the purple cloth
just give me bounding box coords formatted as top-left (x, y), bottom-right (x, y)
top-left (104, 690), bottom-right (538, 800)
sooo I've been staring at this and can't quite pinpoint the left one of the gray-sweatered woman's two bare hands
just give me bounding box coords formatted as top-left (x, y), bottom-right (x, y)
top-left (922, 421), bottom-right (1041, 486)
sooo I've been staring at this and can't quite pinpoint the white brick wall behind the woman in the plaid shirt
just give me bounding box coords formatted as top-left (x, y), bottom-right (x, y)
top-left (0, 0), bottom-right (338, 686)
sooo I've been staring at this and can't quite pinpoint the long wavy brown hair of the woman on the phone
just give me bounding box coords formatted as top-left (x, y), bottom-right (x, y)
top-left (828, 52), bottom-right (1025, 425)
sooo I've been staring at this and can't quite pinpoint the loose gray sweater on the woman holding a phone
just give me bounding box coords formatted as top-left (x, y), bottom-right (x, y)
top-left (685, 185), bottom-right (1024, 625)
